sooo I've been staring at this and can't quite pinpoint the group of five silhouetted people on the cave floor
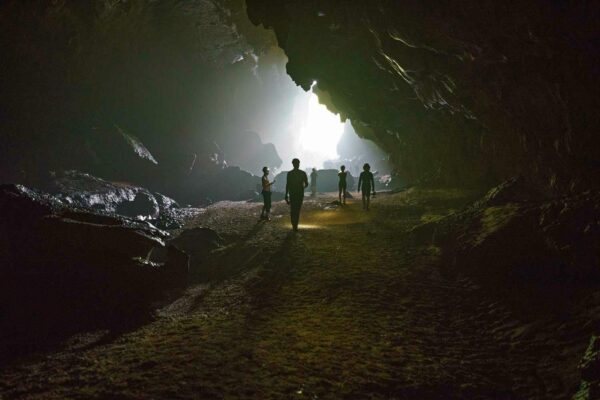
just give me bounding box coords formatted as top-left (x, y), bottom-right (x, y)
top-left (260, 158), bottom-right (375, 231)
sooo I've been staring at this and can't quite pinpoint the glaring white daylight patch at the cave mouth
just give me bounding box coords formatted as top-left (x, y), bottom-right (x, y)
top-left (300, 92), bottom-right (344, 161)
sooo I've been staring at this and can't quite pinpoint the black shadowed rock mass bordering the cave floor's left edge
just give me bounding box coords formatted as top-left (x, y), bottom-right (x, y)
top-left (0, 185), bottom-right (188, 357)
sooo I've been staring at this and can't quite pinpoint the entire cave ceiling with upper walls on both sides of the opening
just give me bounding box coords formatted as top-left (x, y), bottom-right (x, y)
top-left (0, 0), bottom-right (600, 192)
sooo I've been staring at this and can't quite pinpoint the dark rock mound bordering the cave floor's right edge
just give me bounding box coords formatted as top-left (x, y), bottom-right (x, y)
top-left (413, 179), bottom-right (600, 288)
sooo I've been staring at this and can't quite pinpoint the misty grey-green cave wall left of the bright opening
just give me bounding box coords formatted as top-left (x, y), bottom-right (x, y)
top-left (0, 0), bottom-right (297, 185)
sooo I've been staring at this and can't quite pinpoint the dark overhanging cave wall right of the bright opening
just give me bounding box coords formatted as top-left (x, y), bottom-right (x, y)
top-left (247, 0), bottom-right (600, 195)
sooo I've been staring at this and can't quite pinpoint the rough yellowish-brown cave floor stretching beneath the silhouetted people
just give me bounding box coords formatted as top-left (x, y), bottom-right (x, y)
top-left (0, 190), bottom-right (587, 399)
